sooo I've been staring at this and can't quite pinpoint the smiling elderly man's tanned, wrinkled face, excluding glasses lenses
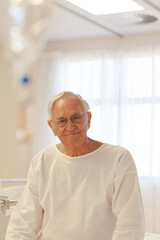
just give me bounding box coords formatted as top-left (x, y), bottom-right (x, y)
top-left (48, 96), bottom-right (91, 147)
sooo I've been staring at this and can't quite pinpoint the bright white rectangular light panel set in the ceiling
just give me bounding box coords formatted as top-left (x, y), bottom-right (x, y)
top-left (66, 0), bottom-right (144, 15)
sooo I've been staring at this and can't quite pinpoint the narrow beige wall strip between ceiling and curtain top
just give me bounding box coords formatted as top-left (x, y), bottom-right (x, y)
top-left (47, 32), bottom-right (160, 52)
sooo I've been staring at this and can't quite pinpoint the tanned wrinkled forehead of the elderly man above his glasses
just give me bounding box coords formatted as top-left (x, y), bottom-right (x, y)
top-left (52, 96), bottom-right (84, 116)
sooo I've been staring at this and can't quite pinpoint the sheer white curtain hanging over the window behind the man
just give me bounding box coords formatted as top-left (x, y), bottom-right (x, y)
top-left (31, 47), bottom-right (160, 233)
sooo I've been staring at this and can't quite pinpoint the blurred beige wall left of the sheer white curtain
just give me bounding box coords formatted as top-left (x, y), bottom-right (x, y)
top-left (0, 47), bottom-right (33, 179)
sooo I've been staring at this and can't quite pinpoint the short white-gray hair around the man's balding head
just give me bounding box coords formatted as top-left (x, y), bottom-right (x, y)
top-left (47, 91), bottom-right (90, 120)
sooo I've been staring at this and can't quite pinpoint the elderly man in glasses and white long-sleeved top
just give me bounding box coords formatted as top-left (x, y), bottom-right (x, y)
top-left (6, 92), bottom-right (144, 240)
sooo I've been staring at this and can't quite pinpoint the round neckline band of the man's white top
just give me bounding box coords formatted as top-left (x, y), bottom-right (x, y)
top-left (54, 143), bottom-right (106, 162)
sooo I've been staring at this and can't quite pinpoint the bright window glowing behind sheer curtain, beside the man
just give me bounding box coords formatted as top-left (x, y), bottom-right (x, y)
top-left (48, 53), bottom-right (160, 177)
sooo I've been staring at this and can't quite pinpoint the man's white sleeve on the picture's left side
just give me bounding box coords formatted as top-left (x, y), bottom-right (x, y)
top-left (5, 158), bottom-right (43, 240)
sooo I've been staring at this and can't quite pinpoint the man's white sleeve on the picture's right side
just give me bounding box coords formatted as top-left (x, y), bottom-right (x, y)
top-left (112, 151), bottom-right (145, 240)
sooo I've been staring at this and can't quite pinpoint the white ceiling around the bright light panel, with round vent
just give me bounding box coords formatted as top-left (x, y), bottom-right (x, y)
top-left (0, 0), bottom-right (160, 46)
